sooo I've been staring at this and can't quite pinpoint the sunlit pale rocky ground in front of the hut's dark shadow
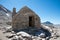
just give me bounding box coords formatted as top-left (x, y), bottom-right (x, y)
top-left (0, 26), bottom-right (60, 40)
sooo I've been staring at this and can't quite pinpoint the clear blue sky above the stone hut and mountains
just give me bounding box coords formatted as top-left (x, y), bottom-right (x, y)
top-left (0, 0), bottom-right (60, 24)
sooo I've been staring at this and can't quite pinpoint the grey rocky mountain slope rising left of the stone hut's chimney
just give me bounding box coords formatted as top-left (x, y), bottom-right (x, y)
top-left (0, 4), bottom-right (12, 23)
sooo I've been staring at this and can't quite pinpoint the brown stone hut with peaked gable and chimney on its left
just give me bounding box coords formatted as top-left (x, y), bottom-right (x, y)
top-left (12, 6), bottom-right (41, 30)
